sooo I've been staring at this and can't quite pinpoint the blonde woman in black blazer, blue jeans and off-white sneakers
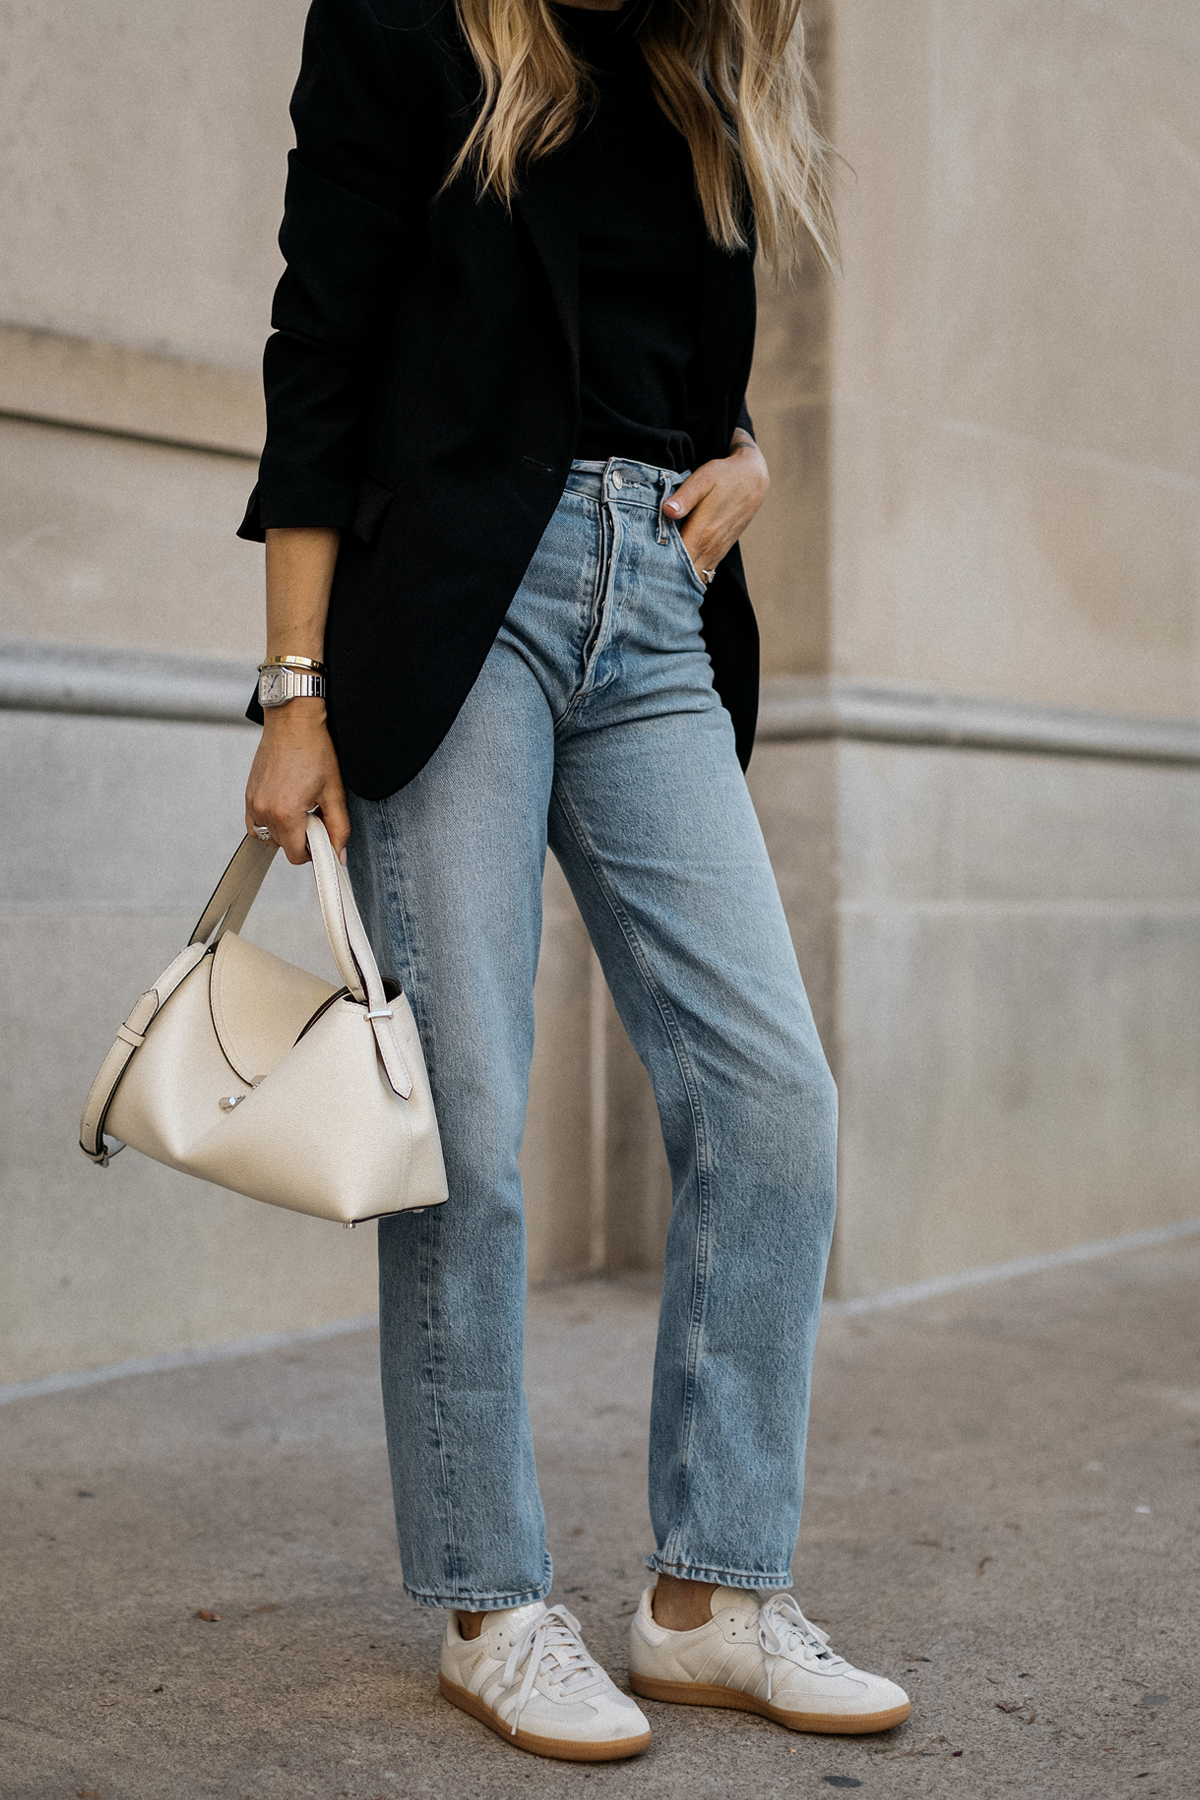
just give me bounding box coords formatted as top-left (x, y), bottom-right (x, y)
top-left (241, 0), bottom-right (909, 1760)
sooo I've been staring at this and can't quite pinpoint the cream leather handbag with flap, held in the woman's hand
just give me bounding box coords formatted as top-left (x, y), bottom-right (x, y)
top-left (79, 815), bottom-right (446, 1226)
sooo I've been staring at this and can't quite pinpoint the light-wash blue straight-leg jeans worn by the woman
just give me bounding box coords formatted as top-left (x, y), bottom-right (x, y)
top-left (349, 461), bottom-right (837, 1611)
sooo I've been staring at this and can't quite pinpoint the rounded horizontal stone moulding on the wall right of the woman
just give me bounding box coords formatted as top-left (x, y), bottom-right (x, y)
top-left (757, 677), bottom-right (1200, 763)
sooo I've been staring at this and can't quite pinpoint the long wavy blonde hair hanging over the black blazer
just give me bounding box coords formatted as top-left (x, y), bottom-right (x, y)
top-left (448, 0), bottom-right (837, 274)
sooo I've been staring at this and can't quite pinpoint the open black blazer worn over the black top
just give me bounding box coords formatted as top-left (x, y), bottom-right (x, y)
top-left (241, 0), bottom-right (757, 799)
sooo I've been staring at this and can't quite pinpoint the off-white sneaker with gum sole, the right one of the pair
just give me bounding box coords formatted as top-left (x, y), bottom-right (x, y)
top-left (630, 1588), bottom-right (912, 1733)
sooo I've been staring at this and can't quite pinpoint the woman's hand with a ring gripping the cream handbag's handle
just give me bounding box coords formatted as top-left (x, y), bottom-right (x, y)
top-left (246, 700), bottom-right (351, 862)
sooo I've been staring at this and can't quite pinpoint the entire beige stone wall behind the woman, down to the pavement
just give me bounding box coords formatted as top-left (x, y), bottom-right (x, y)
top-left (0, 0), bottom-right (1200, 1382)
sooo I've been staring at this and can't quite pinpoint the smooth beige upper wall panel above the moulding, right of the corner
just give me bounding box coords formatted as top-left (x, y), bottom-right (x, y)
top-left (827, 0), bottom-right (1200, 716)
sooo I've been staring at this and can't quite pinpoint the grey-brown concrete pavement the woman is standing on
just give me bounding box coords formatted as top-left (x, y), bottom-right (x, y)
top-left (0, 1240), bottom-right (1200, 1800)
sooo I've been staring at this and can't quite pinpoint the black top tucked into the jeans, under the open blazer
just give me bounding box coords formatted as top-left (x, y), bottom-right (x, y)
top-left (554, 0), bottom-right (705, 470)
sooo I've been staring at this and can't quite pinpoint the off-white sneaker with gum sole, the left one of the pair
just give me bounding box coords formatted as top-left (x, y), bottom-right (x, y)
top-left (437, 1600), bottom-right (649, 1762)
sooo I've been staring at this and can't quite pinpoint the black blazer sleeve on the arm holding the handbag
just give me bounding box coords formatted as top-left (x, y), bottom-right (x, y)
top-left (237, 0), bottom-right (425, 542)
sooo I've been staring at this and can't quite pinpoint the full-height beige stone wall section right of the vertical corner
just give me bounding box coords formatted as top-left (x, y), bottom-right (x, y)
top-left (780, 0), bottom-right (1200, 1294)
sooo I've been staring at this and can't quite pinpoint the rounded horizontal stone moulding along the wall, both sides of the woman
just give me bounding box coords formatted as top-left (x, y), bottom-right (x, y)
top-left (0, 637), bottom-right (1200, 765)
